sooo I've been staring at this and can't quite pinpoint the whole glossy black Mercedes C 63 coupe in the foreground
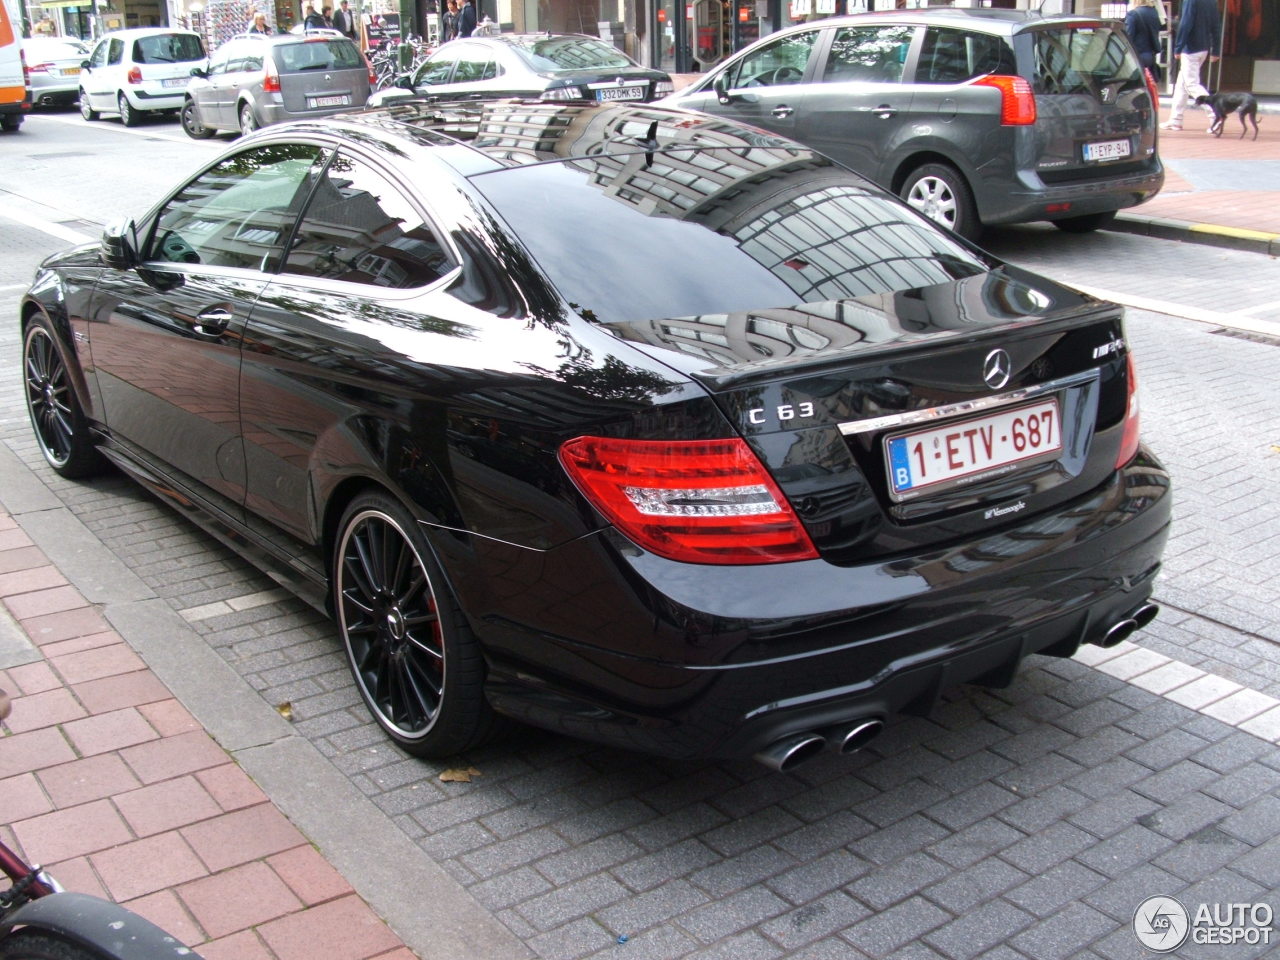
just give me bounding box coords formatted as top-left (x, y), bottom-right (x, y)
top-left (20, 101), bottom-right (1171, 769)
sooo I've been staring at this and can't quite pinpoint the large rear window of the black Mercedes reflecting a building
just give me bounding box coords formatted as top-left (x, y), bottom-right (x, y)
top-left (472, 147), bottom-right (987, 323)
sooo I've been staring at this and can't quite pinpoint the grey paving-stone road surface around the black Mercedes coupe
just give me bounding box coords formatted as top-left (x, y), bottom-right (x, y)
top-left (0, 181), bottom-right (1280, 960)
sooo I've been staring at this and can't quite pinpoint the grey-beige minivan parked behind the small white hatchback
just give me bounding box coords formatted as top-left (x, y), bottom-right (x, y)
top-left (182, 29), bottom-right (372, 140)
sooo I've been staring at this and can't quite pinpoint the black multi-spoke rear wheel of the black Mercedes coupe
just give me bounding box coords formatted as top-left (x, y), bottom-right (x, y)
top-left (330, 492), bottom-right (498, 758)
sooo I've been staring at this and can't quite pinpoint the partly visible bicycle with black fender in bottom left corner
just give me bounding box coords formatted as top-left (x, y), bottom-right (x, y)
top-left (0, 690), bottom-right (200, 960)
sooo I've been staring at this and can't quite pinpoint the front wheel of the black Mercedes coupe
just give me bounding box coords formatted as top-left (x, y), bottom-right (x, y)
top-left (22, 317), bottom-right (105, 479)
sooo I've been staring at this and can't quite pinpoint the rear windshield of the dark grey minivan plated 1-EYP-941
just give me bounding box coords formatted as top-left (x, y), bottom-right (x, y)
top-left (1032, 26), bottom-right (1143, 96)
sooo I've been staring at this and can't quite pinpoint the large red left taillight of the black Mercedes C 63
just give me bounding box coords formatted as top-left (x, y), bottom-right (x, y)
top-left (559, 436), bottom-right (818, 563)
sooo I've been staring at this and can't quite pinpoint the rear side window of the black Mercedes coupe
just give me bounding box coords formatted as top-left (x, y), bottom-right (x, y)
top-left (284, 152), bottom-right (453, 288)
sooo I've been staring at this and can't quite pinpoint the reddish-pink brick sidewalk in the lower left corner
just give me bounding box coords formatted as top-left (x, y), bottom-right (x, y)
top-left (0, 511), bottom-right (413, 960)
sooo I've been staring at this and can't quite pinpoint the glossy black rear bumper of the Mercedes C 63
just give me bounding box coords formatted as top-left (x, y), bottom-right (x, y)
top-left (460, 453), bottom-right (1170, 756)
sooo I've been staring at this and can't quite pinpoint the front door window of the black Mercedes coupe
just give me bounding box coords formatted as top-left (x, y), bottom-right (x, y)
top-left (148, 143), bottom-right (323, 270)
